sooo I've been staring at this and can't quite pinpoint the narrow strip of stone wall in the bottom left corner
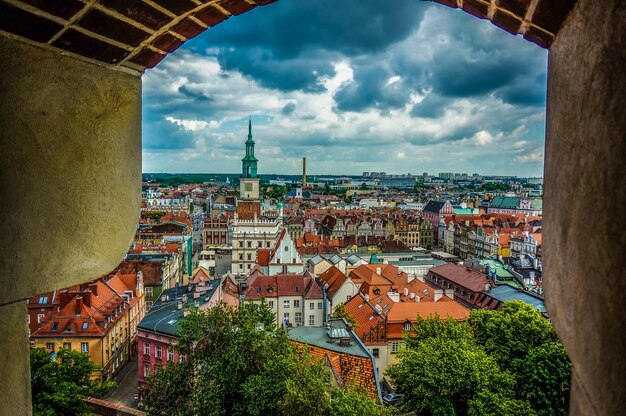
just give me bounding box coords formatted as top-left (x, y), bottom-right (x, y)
top-left (0, 302), bottom-right (31, 416)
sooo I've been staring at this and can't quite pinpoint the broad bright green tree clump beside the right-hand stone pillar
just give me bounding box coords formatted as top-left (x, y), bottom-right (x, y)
top-left (387, 301), bottom-right (571, 416)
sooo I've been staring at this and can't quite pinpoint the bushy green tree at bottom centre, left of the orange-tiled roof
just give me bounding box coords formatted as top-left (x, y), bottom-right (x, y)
top-left (144, 302), bottom-right (373, 416)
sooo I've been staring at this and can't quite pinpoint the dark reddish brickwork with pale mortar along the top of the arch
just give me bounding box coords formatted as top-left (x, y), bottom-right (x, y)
top-left (0, 0), bottom-right (576, 72)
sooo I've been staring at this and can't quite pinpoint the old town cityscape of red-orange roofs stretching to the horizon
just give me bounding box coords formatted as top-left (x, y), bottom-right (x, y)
top-left (28, 121), bottom-right (569, 414)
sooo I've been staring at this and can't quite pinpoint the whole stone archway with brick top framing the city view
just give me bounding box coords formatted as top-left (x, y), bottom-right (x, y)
top-left (0, 0), bottom-right (626, 415)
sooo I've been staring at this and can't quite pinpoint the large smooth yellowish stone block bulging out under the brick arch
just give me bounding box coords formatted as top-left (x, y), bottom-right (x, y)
top-left (0, 35), bottom-right (141, 306)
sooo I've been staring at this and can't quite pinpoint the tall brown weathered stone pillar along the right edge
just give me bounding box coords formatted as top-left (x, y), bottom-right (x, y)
top-left (543, 0), bottom-right (626, 416)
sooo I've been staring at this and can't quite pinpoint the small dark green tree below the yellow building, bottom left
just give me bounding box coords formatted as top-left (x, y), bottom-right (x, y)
top-left (30, 348), bottom-right (116, 416)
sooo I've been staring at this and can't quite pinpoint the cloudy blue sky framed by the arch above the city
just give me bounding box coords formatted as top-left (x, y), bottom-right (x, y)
top-left (143, 0), bottom-right (547, 176)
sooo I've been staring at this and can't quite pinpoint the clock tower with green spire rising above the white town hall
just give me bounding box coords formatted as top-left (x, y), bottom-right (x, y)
top-left (237, 120), bottom-right (261, 220)
